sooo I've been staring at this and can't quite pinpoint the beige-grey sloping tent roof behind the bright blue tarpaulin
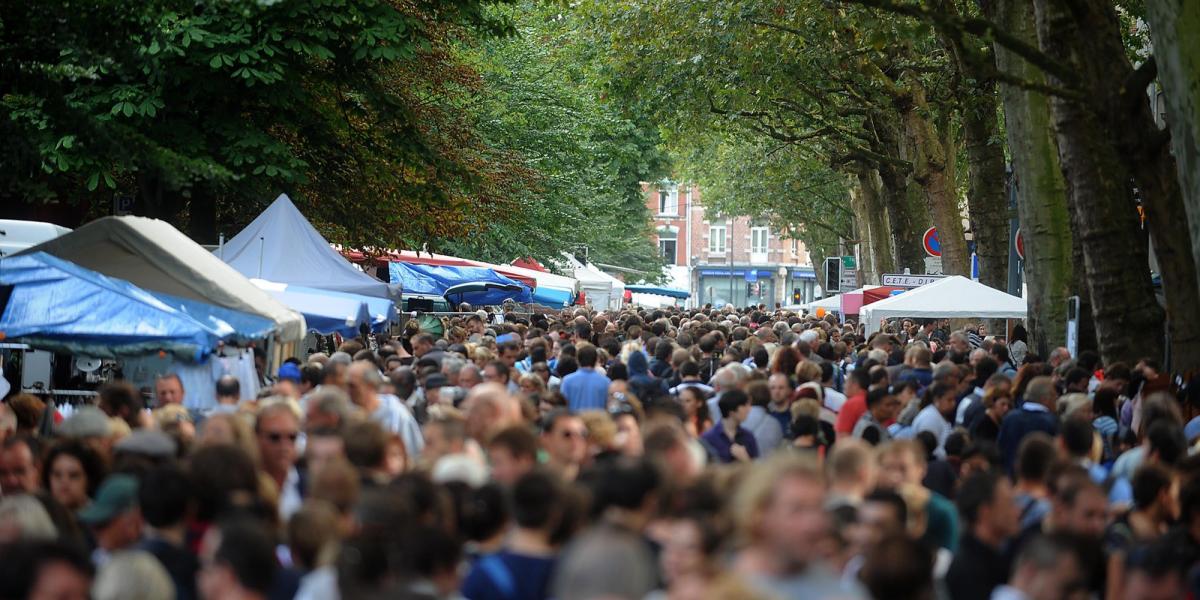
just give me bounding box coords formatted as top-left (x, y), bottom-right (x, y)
top-left (17, 217), bottom-right (305, 342)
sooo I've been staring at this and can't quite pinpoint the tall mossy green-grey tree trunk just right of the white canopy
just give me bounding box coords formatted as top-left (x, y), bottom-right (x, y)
top-left (976, 0), bottom-right (1080, 356)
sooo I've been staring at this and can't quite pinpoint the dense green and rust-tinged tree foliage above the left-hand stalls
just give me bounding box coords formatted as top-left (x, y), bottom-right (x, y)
top-left (0, 0), bottom-right (665, 272)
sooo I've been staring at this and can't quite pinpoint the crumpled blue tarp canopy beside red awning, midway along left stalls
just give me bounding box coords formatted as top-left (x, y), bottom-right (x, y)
top-left (388, 263), bottom-right (533, 306)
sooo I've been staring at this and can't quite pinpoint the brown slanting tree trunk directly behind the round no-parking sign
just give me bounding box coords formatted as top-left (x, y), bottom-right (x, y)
top-left (898, 78), bottom-right (970, 275)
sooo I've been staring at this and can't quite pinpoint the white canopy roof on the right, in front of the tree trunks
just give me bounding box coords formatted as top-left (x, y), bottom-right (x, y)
top-left (863, 275), bottom-right (1027, 334)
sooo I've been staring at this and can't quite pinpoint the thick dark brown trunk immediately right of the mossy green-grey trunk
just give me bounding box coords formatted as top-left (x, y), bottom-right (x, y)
top-left (1034, 0), bottom-right (1163, 362)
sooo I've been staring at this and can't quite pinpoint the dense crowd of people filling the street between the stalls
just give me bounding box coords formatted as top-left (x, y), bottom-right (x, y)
top-left (0, 306), bottom-right (1200, 600)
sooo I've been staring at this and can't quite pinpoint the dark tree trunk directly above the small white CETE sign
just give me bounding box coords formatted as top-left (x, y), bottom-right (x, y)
top-left (871, 119), bottom-right (931, 272)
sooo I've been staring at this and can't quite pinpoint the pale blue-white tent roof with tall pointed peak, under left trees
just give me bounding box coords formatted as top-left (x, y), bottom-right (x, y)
top-left (216, 193), bottom-right (400, 298)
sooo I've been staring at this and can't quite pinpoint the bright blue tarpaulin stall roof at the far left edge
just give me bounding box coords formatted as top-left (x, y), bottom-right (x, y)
top-left (0, 252), bottom-right (233, 361)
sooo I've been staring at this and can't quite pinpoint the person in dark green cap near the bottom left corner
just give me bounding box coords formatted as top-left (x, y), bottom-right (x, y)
top-left (79, 474), bottom-right (142, 568)
